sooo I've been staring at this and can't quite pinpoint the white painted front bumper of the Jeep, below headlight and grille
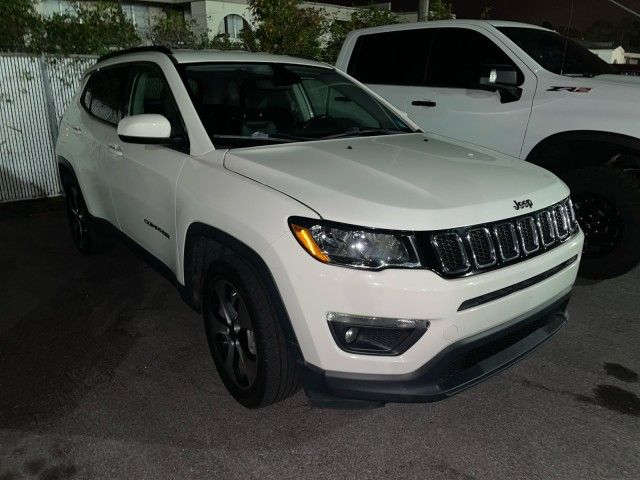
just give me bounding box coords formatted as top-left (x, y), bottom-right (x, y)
top-left (269, 232), bottom-right (584, 378)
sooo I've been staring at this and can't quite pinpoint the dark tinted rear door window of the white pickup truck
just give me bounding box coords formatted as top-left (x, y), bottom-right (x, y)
top-left (347, 28), bottom-right (433, 86)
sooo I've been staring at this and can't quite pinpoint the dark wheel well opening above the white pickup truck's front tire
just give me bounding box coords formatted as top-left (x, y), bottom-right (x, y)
top-left (526, 130), bottom-right (640, 173)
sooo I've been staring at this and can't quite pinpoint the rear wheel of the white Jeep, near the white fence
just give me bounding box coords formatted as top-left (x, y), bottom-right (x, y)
top-left (63, 177), bottom-right (108, 255)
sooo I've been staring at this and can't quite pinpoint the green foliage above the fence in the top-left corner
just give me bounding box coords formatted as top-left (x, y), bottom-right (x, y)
top-left (0, 0), bottom-right (39, 50)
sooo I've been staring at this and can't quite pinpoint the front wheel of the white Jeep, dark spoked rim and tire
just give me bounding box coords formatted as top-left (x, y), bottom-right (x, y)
top-left (202, 253), bottom-right (299, 408)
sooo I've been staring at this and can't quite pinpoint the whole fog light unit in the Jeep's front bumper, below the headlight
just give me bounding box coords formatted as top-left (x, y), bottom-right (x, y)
top-left (327, 312), bottom-right (429, 355)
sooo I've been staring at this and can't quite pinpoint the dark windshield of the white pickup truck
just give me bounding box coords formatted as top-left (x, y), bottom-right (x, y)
top-left (498, 27), bottom-right (618, 77)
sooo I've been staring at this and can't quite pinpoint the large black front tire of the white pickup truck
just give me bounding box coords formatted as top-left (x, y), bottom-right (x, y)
top-left (563, 167), bottom-right (640, 279)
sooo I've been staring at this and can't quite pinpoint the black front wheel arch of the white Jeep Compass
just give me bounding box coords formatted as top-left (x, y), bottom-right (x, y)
top-left (183, 222), bottom-right (302, 352)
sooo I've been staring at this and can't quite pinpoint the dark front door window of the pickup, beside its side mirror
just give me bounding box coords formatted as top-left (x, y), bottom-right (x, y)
top-left (427, 28), bottom-right (524, 88)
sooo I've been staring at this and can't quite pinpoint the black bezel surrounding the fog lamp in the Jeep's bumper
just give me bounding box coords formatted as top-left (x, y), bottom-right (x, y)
top-left (326, 312), bottom-right (431, 356)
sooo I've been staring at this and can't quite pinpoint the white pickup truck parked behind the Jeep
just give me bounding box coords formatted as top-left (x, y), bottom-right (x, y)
top-left (336, 20), bottom-right (640, 278)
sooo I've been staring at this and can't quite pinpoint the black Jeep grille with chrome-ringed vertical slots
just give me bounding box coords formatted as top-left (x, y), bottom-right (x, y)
top-left (428, 199), bottom-right (578, 276)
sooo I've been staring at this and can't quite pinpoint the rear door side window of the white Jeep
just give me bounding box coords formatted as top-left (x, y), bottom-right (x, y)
top-left (81, 66), bottom-right (129, 126)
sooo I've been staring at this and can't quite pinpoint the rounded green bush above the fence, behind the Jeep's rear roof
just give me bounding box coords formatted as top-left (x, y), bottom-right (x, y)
top-left (32, 1), bottom-right (140, 55)
